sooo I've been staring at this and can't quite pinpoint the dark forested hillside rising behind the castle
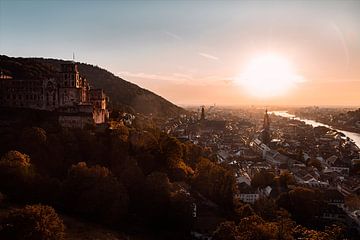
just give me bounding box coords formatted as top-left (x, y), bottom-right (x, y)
top-left (0, 55), bottom-right (185, 117)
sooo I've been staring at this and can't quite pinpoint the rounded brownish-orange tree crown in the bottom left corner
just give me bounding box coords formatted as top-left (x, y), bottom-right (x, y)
top-left (0, 205), bottom-right (64, 240)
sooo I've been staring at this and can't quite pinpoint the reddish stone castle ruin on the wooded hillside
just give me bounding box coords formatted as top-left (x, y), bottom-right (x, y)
top-left (0, 62), bottom-right (109, 128)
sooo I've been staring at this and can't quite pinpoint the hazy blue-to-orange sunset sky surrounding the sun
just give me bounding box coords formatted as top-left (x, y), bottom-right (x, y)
top-left (0, 0), bottom-right (360, 105)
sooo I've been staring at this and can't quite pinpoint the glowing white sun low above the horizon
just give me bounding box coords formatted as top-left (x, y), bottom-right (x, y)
top-left (236, 54), bottom-right (302, 98)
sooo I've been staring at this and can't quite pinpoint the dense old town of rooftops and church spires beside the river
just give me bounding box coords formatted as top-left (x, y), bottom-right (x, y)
top-left (164, 106), bottom-right (360, 233)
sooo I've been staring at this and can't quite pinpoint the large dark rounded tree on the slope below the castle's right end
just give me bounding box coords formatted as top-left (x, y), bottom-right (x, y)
top-left (63, 162), bottom-right (128, 224)
